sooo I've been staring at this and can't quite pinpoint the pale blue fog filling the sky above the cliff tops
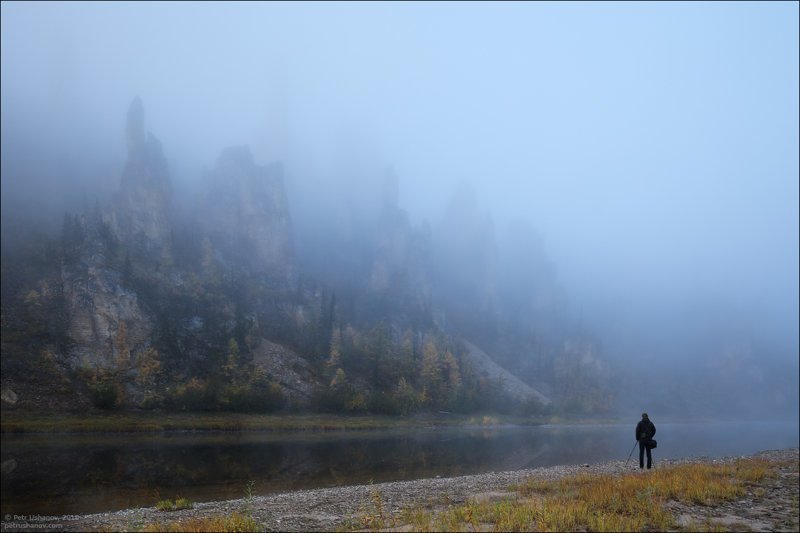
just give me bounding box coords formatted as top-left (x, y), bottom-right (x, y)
top-left (1, 2), bottom-right (800, 414)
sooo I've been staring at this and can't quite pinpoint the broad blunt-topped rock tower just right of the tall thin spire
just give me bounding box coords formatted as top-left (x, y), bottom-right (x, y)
top-left (200, 146), bottom-right (295, 284)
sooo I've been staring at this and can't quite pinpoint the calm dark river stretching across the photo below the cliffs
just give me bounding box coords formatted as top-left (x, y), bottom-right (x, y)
top-left (2, 420), bottom-right (798, 515)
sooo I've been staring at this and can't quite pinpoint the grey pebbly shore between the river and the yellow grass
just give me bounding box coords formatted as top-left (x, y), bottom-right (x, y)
top-left (3, 448), bottom-right (800, 531)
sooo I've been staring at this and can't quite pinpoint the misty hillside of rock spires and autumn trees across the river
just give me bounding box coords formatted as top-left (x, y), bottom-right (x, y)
top-left (2, 98), bottom-right (612, 414)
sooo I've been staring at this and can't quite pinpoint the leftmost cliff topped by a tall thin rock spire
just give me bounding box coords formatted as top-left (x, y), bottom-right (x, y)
top-left (61, 98), bottom-right (171, 384)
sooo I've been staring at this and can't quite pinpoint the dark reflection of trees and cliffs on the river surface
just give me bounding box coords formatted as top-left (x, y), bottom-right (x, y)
top-left (2, 428), bottom-right (664, 514)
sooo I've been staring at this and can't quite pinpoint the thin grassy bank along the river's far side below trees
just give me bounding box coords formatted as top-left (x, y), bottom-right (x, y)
top-left (0, 412), bottom-right (546, 433)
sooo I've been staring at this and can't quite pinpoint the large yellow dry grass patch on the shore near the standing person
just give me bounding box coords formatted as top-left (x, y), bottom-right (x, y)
top-left (388, 459), bottom-right (775, 531)
